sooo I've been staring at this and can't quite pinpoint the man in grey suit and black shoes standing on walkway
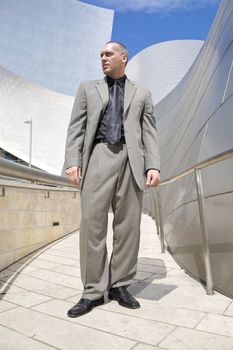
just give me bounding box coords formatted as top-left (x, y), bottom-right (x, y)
top-left (64, 42), bottom-right (160, 317)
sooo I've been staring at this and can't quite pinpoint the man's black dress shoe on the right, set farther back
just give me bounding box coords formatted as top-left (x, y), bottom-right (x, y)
top-left (108, 286), bottom-right (140, 309)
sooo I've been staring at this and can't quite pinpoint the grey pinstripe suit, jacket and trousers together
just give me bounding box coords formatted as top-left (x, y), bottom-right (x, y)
top-left (64, 79), bottom-right (160, 299)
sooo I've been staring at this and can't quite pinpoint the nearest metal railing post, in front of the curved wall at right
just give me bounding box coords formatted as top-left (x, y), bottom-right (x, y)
top-left (195, 169), bottom-right (214, 294)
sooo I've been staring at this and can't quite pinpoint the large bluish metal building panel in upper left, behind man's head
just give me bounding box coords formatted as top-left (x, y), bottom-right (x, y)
top-left (0, 0), bottom-right (114, 96)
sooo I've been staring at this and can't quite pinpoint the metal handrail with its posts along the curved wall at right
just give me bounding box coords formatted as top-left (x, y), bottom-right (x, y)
top-left (156, 148), bottom-right (233, 294)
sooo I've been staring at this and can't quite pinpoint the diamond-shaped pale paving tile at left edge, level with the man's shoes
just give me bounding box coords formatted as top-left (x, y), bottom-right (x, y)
top-left (3, 291), bottom-right (51, 307)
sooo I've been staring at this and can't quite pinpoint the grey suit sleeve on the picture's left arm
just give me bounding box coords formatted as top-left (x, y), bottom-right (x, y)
top-left (63, 84), bottom-right (87, 171)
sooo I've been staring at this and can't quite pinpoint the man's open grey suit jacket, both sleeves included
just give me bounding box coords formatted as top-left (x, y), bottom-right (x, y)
top-left (63, 79), bottom-right (160, 190)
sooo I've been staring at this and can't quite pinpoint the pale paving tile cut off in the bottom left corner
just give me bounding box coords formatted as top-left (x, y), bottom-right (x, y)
top-left (0, 326), bottom-right (54, 350)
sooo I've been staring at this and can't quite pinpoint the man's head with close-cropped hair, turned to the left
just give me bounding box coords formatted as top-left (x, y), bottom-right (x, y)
top-left (100, 43), bottom-right (127, 79)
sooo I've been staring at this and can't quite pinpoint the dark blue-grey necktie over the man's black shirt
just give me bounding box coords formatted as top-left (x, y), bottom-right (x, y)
top-left (105, 81), bottom-right (123, 145)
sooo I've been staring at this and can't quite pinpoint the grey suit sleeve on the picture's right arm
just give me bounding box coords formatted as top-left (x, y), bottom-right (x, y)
top-left (142, 91), bottom-right (160, 172)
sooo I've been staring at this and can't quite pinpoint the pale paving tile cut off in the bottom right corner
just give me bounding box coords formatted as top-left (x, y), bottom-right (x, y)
top-left (159, 327), bottom-right (233, 350)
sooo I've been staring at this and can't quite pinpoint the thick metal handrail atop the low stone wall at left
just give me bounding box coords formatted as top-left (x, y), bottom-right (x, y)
top-left (0, 158), bottom-right (77, 190)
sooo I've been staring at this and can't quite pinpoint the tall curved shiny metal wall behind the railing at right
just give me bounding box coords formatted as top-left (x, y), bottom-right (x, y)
top-left (144, 0), bottom-right (233, 297)
